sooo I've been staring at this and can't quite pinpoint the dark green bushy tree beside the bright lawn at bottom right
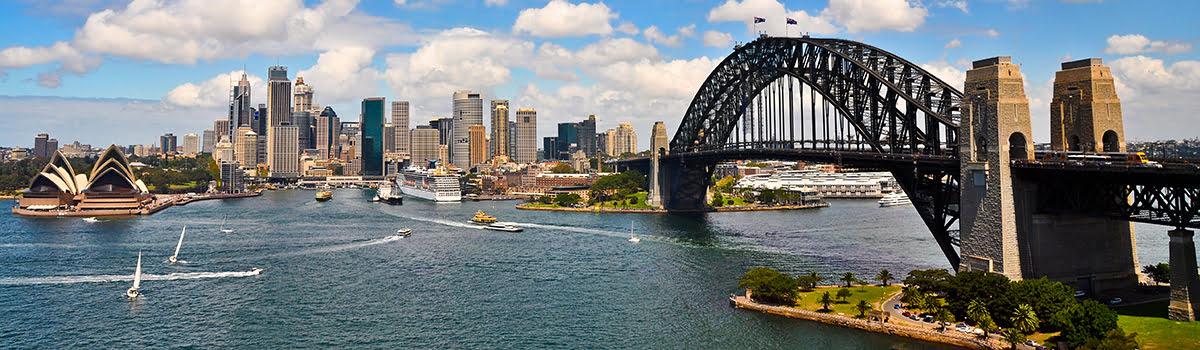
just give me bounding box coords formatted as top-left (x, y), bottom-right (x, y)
top-left (1048, 300), bottom-right (1117, 348)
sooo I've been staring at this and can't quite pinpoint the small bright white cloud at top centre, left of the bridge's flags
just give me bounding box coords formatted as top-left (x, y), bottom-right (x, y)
top-left (512, 0), bottom-right (617, 37)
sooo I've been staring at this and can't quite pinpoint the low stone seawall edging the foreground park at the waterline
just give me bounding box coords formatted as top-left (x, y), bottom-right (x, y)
top-left (730, 295), bottom-right (1004, 350)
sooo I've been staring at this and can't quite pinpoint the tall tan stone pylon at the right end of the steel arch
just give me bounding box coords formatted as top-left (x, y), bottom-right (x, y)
top-left (959, 56), bottom-right (1033, 279)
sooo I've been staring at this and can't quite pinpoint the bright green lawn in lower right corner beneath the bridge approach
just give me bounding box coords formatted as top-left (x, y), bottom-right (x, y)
top-left (1115, 300), bottom-right (1200, 349)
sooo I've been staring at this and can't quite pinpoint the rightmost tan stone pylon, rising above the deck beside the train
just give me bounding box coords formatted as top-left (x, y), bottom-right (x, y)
top-left (1050, 59), bottom-right (1124, 152)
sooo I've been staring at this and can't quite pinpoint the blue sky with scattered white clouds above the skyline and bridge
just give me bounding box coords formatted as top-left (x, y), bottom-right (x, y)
top-left (0, 0), bottom-right (1200, 147)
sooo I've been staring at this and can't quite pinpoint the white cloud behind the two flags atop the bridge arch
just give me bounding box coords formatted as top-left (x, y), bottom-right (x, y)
top-left (708, 0), bottom-right (838, 36)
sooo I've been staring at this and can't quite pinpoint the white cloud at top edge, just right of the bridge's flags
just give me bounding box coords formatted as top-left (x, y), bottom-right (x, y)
top-left (822, 0), bottom-right (929, 34)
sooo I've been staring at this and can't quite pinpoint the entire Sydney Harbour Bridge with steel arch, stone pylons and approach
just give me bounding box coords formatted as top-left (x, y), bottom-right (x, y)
top-left (619, 36), bottom-right (1200, 320)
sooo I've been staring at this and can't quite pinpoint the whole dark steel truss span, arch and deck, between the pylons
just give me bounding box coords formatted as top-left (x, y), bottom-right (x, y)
top-left (665, 36), bottom-right (962, 266)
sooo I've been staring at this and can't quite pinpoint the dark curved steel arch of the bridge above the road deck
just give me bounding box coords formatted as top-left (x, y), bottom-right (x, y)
top-left (670, 37), bottom-right (962, 156)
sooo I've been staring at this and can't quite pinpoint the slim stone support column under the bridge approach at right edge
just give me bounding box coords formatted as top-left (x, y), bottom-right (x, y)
top-left (1166, 229), bottom-right (1200, 321)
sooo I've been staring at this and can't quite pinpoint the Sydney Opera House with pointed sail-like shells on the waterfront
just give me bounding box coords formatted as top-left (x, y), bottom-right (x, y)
top-left (13, 146), bottom-right (154, 216)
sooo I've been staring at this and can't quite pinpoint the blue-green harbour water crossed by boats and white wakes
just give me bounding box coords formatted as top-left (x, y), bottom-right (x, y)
top-left (0, 189), bottom-right (1166, 349)
